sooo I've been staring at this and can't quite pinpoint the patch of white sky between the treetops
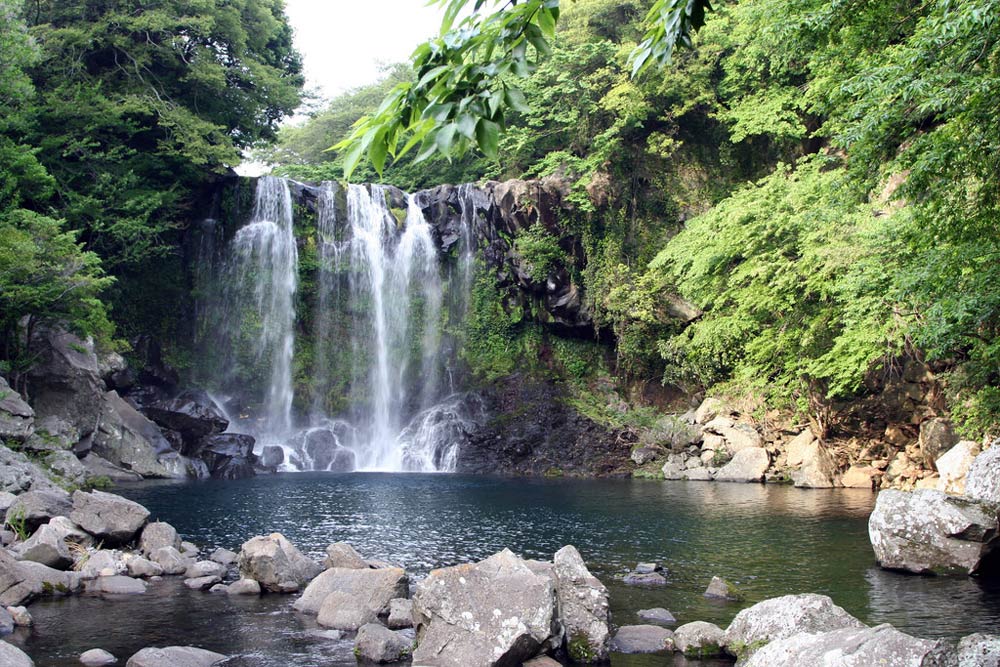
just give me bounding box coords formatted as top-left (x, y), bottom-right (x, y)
top-left (285, 0), bottom-right (442, 98)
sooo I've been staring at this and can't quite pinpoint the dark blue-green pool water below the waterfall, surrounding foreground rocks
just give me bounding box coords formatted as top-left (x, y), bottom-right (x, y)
top-left (8, 473), bottom-right (1000, 667)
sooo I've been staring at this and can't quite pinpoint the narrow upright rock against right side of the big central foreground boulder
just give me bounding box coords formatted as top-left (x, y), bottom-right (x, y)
top-left (552, 545), bottom-right (608, 663)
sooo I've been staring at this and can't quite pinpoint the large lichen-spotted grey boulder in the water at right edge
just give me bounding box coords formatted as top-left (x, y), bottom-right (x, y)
top-left (868, 489), bottom-right (998, 574)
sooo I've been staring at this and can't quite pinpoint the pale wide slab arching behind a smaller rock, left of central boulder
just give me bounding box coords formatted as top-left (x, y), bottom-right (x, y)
top-left (293, 567), bottom-right (410, 614)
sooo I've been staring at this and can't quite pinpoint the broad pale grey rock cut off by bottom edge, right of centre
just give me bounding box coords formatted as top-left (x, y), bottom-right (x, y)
top-left (741, 624), bottom-right (941, 667)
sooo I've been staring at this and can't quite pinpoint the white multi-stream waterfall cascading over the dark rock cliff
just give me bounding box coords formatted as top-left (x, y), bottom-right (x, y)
top-left (200, 178), bottom-right (483, 472)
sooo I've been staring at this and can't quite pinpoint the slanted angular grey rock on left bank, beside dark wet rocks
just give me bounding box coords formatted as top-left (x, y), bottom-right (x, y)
top-left (90, 391), bottom-right (172, 478)
